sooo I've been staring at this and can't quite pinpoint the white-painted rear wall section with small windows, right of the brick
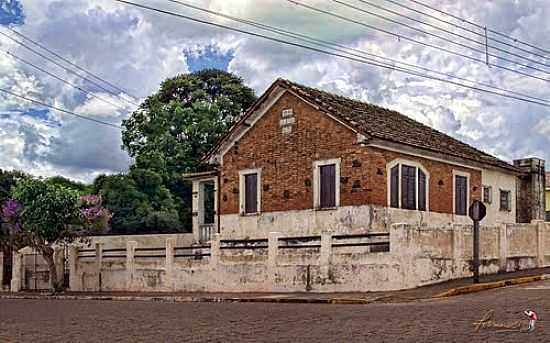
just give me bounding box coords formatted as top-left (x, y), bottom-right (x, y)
top-left (481, 169), bottom-right (517, 225)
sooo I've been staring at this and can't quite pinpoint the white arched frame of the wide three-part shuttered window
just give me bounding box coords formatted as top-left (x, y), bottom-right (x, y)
top-left (386, 158), bottom-right (430, 212)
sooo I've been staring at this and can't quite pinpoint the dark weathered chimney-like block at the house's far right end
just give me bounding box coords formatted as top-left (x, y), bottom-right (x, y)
top-left (514, 158), bottom-right (545, 223)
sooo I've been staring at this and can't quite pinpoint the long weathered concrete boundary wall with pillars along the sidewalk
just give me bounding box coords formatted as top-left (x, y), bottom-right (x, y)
top-left (58, 221), bottom-right (550, 292)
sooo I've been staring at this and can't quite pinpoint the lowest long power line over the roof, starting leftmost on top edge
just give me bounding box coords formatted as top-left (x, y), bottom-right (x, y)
top-left (115, 0), bottom-right (550, 107)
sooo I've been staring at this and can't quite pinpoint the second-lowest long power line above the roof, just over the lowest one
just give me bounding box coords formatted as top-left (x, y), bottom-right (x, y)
top-left (168, 0), bottom-right (550, 103)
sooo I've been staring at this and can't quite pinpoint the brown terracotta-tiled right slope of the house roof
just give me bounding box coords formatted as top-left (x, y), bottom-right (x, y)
top-left (279, 79), bottom-right (520, 173)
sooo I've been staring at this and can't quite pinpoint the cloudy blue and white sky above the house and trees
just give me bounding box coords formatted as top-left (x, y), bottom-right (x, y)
top-left (0, 0), bottom-right (550, 182)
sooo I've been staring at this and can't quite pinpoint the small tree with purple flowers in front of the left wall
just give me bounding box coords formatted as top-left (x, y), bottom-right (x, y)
top-left (0, 178), bottom-right (111, 291)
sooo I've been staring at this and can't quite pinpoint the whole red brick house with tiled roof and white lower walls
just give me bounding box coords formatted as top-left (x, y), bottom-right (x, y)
top-left (186, 79), bottom-right (540, 240)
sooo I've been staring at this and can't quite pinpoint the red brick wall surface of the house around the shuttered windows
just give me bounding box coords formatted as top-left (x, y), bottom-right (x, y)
top-left (220, 93), bottom-right (481, 214)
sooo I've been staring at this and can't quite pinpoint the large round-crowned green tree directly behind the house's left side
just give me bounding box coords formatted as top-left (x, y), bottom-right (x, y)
top-left (122, 69), bottom-right (256, 231)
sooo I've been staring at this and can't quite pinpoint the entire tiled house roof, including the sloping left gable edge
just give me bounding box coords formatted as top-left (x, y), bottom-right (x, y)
top-left (207, 79), bottom-right (518, 172)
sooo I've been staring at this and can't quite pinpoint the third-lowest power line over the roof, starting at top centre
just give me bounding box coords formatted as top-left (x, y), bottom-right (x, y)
top-left (286, 0), bottom-right (550, 82)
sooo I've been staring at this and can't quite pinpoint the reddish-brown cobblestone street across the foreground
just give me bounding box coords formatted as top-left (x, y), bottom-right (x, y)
top-left (0, 281), bottom-right (550, 342)
